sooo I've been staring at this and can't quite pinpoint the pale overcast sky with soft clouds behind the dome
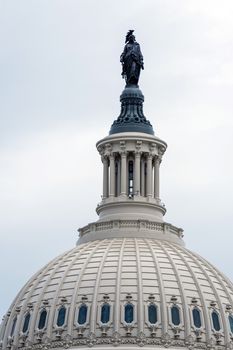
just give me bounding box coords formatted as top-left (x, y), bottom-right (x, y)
top-left (0, 0), bottom-right (233, 316)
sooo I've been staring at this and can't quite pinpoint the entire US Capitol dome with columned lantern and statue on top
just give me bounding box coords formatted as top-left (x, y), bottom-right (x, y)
top-left (0, 31), bottom-right (233, 350)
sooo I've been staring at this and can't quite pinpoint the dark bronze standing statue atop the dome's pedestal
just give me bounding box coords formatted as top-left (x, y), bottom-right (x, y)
top-left (120, 30), bottom-right (144, 85)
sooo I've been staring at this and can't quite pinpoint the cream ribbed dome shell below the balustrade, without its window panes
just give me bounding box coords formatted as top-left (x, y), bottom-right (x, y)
top-left (1, 238), bottom-right (233, 349)
